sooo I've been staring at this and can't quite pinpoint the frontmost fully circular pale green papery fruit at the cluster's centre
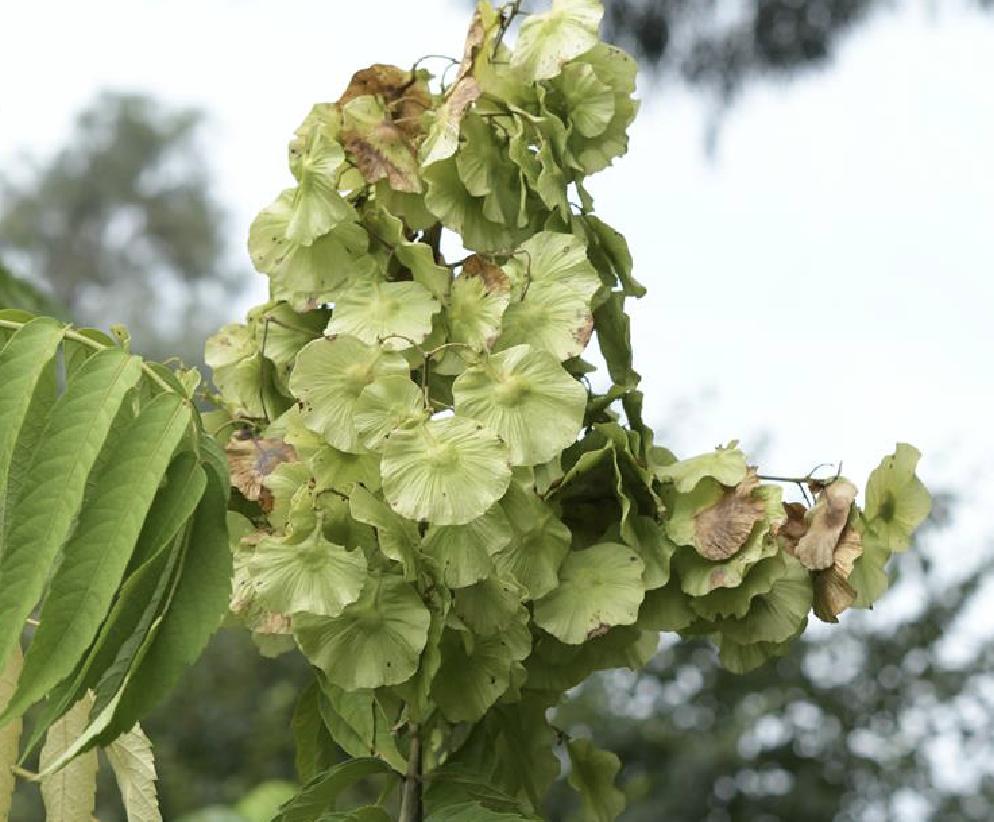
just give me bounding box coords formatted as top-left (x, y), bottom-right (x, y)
top-left (380, 417), bottom-right (511, 525)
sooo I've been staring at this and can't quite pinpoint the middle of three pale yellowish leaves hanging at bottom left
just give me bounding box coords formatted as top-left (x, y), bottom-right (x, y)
top-left (38, 695), bottom-right (97, 822)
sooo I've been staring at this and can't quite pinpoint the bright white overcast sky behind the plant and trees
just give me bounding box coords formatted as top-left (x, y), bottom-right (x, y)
top-left (0, 0), bottom-right (994, 564)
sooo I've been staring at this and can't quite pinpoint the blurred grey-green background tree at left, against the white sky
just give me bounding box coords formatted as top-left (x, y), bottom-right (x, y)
top-left (0, 93), bottom-right (244, 362)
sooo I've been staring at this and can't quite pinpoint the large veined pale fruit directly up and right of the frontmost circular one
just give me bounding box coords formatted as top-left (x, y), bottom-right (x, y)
top-left (452, 345), bottom-right (587, 465)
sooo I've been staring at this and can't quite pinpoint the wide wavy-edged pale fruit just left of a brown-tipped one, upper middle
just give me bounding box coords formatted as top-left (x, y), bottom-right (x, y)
top-left (325, 280), bottom-right (442, 351)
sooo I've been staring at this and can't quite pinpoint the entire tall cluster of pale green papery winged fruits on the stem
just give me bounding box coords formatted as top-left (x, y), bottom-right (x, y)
top-left (208, 0), bottom-right (927, 822)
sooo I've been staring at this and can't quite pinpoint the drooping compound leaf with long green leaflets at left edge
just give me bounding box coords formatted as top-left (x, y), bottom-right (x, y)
top-left (0, 311), bottom-right (231, 800)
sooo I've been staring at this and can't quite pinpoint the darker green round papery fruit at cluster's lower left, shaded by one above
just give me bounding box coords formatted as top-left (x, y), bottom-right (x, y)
top-left (293, 576), bottom-right (429, 691)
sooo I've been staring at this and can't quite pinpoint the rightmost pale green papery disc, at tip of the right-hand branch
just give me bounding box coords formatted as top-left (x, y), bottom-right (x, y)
top-left (864, 443), bottom-right (932, 551)
